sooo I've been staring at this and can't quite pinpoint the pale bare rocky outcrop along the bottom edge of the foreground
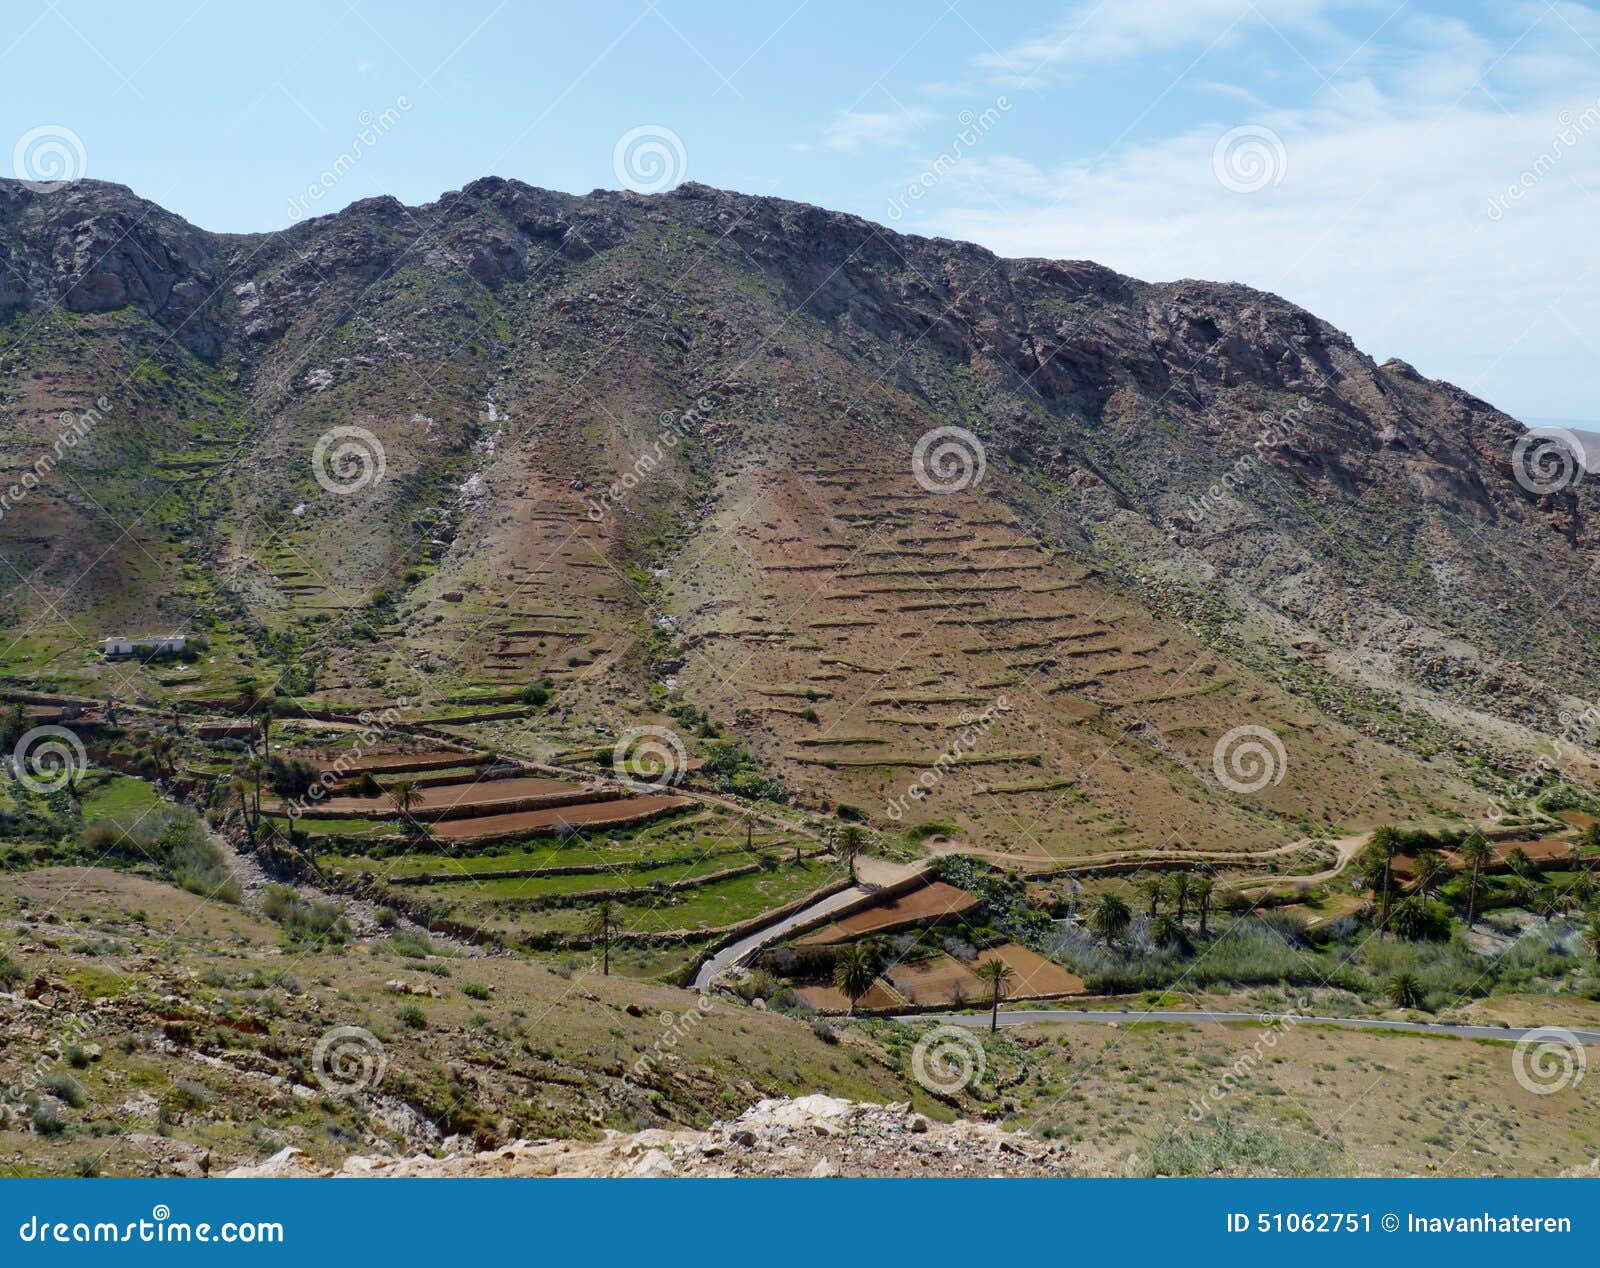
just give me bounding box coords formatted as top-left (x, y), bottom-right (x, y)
top-left (229, 1095), bottom-right (1090, 1178)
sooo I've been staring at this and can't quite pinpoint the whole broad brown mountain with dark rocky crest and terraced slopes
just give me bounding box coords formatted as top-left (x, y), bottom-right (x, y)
top-left (0, 179), bottom-right (1600, 857)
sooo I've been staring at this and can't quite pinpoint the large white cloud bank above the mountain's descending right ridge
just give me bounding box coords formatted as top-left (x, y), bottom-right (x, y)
top-left (896, 0), bottom-right (1600, 418)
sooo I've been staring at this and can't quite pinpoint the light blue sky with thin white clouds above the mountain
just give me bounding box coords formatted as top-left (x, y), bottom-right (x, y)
top-left (0, 0), bottom-right (1600, 423)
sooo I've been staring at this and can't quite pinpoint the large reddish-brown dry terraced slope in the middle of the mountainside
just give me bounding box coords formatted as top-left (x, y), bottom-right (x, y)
top-left (667, 454), bottom-right (1466, 860)
